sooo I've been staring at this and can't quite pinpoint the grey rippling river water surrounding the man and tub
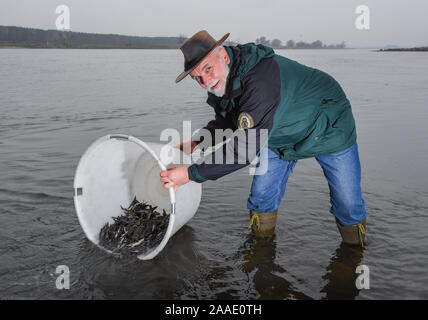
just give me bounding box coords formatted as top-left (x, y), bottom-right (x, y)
top-left (0, 49), bottom-right (428, 299)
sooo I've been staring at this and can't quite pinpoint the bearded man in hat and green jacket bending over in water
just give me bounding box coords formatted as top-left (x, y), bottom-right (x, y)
top-left (160, 30), bottom-right (367, 246)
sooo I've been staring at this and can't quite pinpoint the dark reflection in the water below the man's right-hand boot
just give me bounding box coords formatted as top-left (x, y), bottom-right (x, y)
top-left (321, 242), bottom-right (364, 300)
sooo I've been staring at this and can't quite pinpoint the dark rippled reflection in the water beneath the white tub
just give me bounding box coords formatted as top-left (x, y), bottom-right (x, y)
top-left (74, 226), bottom-right (200, 299)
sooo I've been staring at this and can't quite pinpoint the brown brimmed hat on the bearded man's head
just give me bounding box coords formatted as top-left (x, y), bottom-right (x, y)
top-left (175, 30), bottom-right (230, 83)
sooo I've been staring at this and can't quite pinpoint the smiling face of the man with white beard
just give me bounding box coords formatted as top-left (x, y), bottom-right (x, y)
top-left (190, 48), bottom-right (230, 97)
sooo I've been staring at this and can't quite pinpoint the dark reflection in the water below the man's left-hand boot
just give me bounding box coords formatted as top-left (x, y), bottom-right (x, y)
top-left (241, 234), bottom-right (311, 300)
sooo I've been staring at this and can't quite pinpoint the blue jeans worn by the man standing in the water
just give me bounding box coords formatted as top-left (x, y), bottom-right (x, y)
top-left (247, 143), bottom-right (367, 227)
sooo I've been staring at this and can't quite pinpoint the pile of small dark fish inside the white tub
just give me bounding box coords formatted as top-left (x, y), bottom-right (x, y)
top-left (99, 197), bottom-right (169, 255)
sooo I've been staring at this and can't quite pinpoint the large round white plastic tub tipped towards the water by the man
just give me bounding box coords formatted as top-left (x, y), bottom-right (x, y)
top-left (74, 134), bottom-right (202, 260)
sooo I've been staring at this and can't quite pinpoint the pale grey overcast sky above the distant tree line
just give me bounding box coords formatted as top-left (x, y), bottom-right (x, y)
top-left (0, 0), bottom-right (428, 47)
